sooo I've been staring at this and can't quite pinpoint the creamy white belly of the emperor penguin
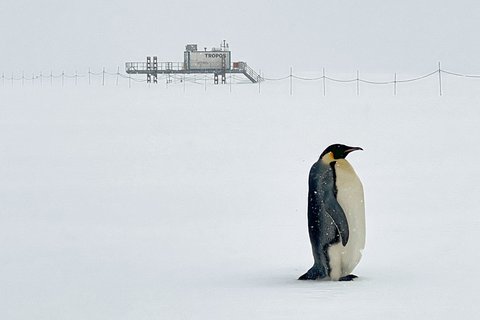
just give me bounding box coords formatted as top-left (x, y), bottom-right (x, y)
top-left (328, 159), bottom-right (365, 280)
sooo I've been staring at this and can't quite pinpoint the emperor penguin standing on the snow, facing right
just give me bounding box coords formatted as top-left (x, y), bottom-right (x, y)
top-left (299, 144), bottom-right (365, 281)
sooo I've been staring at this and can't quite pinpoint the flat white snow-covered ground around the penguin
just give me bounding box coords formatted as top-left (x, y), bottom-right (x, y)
top-left (0, 79), bottom-right (480, 320)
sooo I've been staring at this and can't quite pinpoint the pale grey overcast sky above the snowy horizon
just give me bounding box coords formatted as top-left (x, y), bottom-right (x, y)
top-left (0, 0), bottom-right (480, 76)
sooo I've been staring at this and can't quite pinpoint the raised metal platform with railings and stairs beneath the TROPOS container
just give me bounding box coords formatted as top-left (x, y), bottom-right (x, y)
top-left (125, 57), bottom-right (263, 84)
